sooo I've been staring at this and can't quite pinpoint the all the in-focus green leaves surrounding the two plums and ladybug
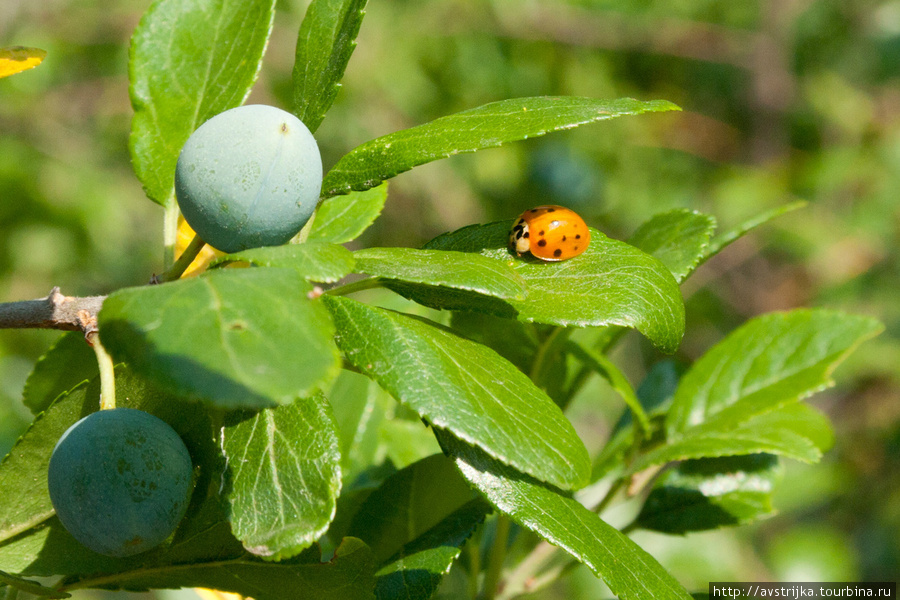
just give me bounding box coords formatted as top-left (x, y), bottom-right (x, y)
top-left (0, 0), bottom-right (880, 600)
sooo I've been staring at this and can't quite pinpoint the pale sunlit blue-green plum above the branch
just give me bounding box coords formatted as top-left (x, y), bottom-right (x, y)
top-left (175, 104), bottom-right (322, 252)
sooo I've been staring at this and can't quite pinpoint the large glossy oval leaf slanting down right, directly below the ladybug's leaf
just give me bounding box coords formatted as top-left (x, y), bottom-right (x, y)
top-left (325, 296), bottom-right (590, 489)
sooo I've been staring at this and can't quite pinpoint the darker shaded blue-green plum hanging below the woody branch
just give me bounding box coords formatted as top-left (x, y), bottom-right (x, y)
top-left (47, 408), bottom-right (192, 557)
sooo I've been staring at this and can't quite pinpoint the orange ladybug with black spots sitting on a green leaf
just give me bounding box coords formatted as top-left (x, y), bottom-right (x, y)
top-left (509, 206), bottom-right (591, 261)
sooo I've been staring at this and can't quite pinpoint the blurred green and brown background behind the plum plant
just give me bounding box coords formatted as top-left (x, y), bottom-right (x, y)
top-left (0, 0), bottom-right (900, 598)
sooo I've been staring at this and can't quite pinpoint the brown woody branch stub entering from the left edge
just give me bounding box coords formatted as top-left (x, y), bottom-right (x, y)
top-left (0, 287), bottom-right (106, 336)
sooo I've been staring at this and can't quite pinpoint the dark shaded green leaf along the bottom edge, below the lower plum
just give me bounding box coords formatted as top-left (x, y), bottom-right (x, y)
top-left (60, 538), bottom-right (375, 600)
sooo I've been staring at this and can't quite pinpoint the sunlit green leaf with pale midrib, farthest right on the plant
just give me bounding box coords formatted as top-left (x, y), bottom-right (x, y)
top-left (666, 310), bottom-right (883, 442)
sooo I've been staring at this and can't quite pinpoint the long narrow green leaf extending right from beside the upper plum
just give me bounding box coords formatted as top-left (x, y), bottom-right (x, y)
top-left (322, 96), bottom-right (679, 198)
